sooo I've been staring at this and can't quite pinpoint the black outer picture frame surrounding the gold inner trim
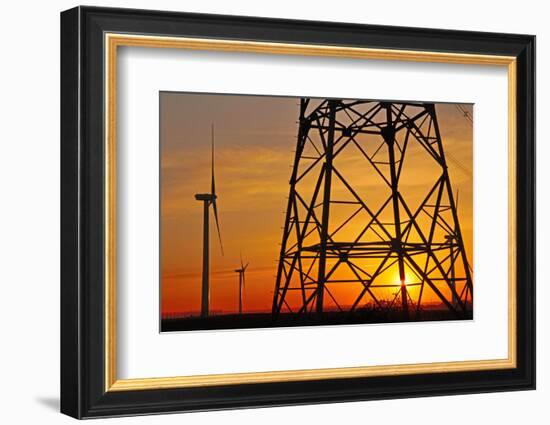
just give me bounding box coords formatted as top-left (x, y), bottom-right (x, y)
top-left (61, 7), bottom-right (535, 418)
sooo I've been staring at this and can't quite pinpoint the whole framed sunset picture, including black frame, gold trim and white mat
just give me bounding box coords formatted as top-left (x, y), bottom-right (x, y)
top-left (61, 7), bottom-right (535, 418)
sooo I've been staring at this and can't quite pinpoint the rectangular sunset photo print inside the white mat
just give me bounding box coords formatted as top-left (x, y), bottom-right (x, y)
top-left (159, 92), bottom-right (474, 332)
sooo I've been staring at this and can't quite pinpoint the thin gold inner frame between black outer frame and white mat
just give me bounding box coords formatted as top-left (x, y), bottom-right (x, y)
top-left (104, 33), bottom-right (517, 391)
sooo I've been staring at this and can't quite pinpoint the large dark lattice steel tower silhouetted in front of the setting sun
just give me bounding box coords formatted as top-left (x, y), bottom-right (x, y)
top-left (272, 98), bottom-right (472, 319)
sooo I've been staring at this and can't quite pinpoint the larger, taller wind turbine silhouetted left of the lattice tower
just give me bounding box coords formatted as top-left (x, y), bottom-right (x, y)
top-left (195, 124), bottom-right (223, 317)
